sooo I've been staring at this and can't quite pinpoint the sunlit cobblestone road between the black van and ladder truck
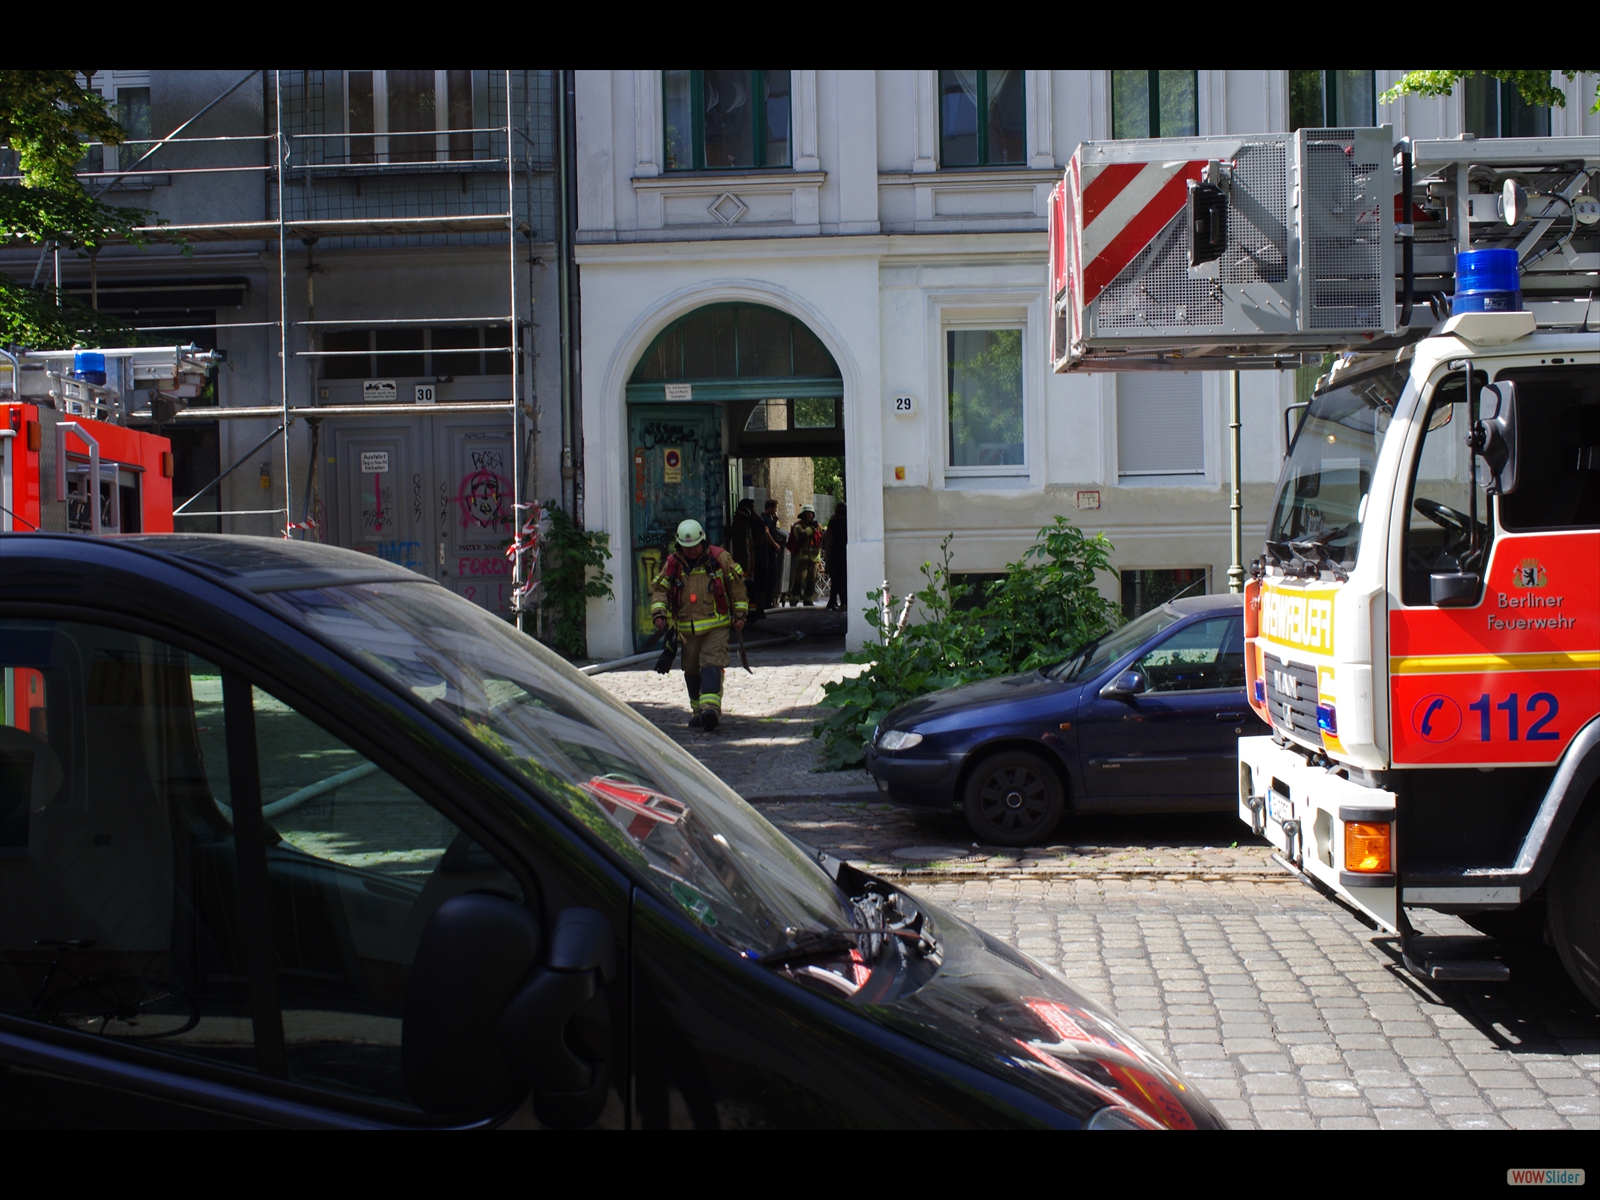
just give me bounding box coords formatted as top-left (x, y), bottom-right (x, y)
top-left (915, 878), bottom-right (1600, 1130)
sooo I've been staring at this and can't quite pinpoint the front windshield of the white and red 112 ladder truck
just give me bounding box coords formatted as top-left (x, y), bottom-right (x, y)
top-left (1267, 363), bottom-right (1408, 566)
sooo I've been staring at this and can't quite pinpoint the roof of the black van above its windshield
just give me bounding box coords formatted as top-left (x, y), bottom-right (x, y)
top-left (106, 533), bottom-right (437, 592)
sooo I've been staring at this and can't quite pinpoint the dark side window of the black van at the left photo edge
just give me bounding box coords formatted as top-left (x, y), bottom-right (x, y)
top-left (0, 619), bottom-right (256, 1070)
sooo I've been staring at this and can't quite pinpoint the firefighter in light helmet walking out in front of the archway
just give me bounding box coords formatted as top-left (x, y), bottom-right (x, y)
top-left (650, 520), bottom-right (749, 733)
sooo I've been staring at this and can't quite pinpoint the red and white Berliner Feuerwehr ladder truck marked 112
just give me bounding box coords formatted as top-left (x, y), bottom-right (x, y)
top-left (1051, 126), bottom-right (1600, 1005)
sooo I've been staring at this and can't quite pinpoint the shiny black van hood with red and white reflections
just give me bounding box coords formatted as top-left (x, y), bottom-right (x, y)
top-left (861, 898), bottom-right (1226, 1130)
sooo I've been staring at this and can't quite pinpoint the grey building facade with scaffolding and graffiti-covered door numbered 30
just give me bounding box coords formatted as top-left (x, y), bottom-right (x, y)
top-left (5, 70), bottom-right (571, 630)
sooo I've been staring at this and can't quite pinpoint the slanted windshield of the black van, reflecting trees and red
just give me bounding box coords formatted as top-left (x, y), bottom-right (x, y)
top-left (252, 582), bottom-right (854, 955)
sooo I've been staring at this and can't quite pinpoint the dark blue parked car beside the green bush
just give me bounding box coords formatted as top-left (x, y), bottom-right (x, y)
top-left (867, 595), bottom-right (1267, 846)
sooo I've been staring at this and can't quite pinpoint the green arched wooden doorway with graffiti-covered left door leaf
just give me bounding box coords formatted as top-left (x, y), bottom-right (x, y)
top-left (627, 304), bottom-right (845, 646)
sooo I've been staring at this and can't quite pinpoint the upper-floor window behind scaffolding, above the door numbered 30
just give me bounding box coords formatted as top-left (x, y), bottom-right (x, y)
top-left (344, 70), bottom-right (488, 163)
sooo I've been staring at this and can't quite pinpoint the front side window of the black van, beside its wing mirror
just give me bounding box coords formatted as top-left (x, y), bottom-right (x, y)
top-left (251, 688), bottom-right (522, 1104)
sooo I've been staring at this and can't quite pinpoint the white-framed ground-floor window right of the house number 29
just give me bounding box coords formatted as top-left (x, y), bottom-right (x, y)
top-left (944, 334), bottom-right (1026, 475)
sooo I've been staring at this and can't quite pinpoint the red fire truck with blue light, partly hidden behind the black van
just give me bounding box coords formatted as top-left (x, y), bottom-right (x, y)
top-left (0, 346), bottom-right (218, 534)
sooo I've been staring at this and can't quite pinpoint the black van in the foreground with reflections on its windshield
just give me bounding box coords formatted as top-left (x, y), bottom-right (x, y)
top-left (0, 534), bottom-right (1221, 1128)
